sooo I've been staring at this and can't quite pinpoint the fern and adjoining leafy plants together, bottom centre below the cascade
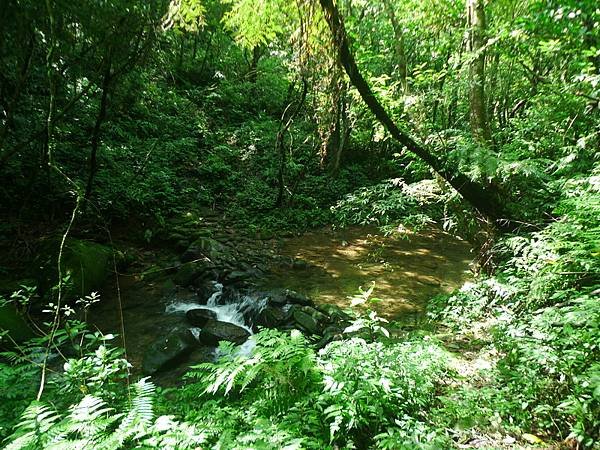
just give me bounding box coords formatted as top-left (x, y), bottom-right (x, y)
top-left (161, 330), bottom-right (449, 448)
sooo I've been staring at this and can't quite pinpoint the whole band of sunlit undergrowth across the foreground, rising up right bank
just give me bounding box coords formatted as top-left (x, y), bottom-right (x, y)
top-left (0, 166), bottom-right (600, 449)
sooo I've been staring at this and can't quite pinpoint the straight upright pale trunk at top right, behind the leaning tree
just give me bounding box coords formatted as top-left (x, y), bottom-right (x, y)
top-left (467, 0), bottom-right (492, 142)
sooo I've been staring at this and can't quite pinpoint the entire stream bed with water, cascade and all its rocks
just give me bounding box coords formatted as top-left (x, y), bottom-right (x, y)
top-left (89, 218), bottom-right (472, 384)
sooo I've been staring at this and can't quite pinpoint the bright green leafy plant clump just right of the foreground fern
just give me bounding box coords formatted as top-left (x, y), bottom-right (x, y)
top-left (318, 338), bottom-right (447, 443)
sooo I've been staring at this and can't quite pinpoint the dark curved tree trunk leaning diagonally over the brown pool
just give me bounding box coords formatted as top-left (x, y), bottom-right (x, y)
top-left (319, 0), bottom-right (512, 229)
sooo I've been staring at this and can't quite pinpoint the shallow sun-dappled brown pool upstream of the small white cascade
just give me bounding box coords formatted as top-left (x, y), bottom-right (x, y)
top-left (265, 227), bottom-right (472, 319)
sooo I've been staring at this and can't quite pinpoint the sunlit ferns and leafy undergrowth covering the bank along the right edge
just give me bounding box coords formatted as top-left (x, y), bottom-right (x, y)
top-left (429, 168), bottom-right (600, 447)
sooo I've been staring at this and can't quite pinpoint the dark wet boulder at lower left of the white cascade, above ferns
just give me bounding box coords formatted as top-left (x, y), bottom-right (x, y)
top-left (142, 328), bottom-right (198, 375)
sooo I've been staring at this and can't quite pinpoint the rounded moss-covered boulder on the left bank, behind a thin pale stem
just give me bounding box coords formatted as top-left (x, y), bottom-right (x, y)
top-left (38, 239), bottom-right (113, 298)
